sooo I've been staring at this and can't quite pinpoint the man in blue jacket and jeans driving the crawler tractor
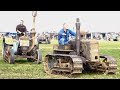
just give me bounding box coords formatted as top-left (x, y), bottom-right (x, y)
top-left (58, 23), bottom-right (76, 45)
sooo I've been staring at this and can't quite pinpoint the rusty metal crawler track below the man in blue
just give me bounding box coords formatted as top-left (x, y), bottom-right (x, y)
top-left (44, 54), bottom-right (83, 74)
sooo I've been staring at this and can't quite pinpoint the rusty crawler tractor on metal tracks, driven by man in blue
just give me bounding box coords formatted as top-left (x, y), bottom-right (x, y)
top-left (44, 18), bottom-right (117, 75)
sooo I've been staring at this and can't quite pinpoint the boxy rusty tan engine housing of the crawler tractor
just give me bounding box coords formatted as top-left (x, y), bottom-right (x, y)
top-left (80, 40), bottom-right (99, 62)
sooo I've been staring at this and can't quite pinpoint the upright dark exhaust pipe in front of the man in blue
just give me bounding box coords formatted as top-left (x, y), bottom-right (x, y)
top-left (76, 18), bottom-right (80, 56)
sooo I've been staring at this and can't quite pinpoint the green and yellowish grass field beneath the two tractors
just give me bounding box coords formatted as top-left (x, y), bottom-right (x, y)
top-left (0, 40), bottom-right (120, 79)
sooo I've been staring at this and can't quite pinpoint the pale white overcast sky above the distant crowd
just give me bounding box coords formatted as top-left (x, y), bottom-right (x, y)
top-left (0, 11), bottom-right (120, 33)
